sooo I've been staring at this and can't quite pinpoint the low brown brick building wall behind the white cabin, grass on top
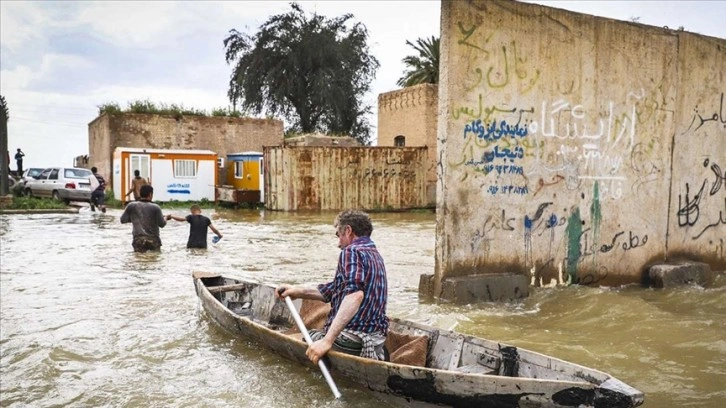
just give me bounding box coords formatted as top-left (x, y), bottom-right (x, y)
top-left (88, 113), bottom-right (283, 190)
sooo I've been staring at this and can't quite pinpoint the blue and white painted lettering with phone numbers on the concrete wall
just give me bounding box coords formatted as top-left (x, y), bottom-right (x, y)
top-left (450, 90), bottom-right (662, 199)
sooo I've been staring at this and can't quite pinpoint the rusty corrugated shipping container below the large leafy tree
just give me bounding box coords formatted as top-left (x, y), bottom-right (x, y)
top-left (263, 146), bottom-right (428, 211)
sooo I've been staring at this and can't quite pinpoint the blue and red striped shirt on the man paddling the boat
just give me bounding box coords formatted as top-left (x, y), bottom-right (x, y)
top-left (318, 237), bottom-right (388, 333)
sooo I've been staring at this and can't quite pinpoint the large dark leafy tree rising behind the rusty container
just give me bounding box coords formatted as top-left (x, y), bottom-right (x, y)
top-left (224, 3), bottom-right (380, 144)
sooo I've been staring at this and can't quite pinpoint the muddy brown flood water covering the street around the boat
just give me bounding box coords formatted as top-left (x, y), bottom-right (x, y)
top-left (0, 209), bottom-right (726, 408)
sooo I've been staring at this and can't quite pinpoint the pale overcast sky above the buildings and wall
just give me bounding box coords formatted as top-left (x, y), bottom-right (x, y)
top-left (0, 1), bottom-right (726, 170)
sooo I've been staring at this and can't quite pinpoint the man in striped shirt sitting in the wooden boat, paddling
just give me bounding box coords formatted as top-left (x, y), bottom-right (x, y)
top-left (275, 210), bottom-right (388, 364)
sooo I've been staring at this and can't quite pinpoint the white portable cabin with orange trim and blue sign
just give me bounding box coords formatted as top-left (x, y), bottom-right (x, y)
top-left (113, 147), bottom-right (217, 201)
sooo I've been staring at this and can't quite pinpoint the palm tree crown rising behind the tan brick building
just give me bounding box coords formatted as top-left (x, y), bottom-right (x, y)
top-left (396, 36), bottom-right (439, 87)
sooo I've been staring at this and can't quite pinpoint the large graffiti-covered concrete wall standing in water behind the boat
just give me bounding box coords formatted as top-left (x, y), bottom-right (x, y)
top-left (432, 1), bottom-right (726, 295)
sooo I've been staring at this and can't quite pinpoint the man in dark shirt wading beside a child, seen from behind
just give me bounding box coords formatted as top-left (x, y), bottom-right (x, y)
top-left (121, 184), bottom-right (166, 252)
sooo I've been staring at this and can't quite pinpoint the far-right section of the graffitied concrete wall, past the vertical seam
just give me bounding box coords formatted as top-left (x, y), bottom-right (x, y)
top-left (672, 32), bottom-right (726, 270)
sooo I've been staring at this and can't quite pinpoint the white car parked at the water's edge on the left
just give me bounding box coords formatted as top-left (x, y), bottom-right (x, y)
top-left (23, 167), bottom-right (98, 204)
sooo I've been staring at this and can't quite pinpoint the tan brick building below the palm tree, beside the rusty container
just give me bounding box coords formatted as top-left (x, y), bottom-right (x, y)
top-left (378, 84), bottom-right (439, 207)
